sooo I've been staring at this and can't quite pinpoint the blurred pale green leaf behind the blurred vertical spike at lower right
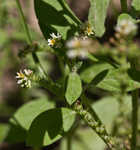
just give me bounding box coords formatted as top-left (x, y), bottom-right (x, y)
top-left (92, 96), bottom-right (131, 132)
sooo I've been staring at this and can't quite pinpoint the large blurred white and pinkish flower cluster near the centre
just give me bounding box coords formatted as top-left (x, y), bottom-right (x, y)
top-left (66, 37), bottom-right (91, 59)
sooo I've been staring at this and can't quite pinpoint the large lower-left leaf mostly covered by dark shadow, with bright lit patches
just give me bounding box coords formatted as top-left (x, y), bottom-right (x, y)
top-left (26, 108), bottom-right (75, 147)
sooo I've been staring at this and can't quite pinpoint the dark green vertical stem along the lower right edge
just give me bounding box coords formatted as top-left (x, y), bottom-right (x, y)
top-left (131, 89), bottom-right (139, 150)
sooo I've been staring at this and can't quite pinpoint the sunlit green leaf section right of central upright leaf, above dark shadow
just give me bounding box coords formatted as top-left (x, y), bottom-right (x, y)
top-left (80, 63), bottom-right (113, 83)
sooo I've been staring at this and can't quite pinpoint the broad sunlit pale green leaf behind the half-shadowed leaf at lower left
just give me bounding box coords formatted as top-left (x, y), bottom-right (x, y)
top-left (10, 99), bottom-right (54, 130)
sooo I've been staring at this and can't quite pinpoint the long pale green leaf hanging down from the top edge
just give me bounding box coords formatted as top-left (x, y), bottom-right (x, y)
top-left (88, 0), bottom-right (110, 37)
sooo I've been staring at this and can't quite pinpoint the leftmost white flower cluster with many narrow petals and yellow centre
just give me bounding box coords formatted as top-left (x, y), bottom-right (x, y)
top-left (16, 69), bottom-right (33, 88)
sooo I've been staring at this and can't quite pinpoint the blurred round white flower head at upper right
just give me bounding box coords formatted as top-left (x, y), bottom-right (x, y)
top-left (115, 19), bottom-right (137, 36)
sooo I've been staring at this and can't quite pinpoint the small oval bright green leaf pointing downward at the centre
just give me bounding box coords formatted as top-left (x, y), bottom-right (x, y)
top-left (65, 72), bottom-right (82, 105)
